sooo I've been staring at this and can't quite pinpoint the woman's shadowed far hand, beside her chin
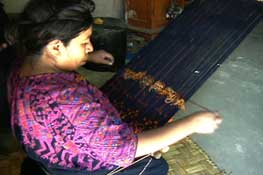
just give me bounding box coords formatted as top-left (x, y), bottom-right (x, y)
top-left (88, 50), bottom-right (114, 65)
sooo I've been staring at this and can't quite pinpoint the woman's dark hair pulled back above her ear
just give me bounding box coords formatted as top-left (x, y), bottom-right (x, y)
top-left (6, 0), bottom-right (95, 56)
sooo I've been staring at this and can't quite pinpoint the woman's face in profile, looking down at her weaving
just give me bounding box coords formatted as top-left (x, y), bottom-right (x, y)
top-left (57, 27), bottom-right (93, 71)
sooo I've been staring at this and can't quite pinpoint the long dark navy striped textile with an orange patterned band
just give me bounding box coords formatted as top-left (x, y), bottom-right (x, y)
top-left (102, 0), bottom-right (262, 130)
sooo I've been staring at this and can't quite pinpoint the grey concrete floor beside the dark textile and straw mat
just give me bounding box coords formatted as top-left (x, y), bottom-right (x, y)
top-left (80, 22), bottom-right (263, 175)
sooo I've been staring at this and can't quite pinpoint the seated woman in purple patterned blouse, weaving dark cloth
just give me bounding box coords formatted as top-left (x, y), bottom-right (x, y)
top-left (6, 0), bottom-right (222, 175)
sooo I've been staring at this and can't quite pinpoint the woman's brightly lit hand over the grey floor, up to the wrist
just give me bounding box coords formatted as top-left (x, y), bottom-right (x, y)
top-left (190, 112), bottom-right (222, 134)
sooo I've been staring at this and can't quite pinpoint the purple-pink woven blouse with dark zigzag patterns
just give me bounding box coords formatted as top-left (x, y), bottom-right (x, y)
top-left (8, 72), bottom-right (137, 172)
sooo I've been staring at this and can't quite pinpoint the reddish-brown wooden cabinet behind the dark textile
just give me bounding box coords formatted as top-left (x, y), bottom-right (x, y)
top-left (126, 0), bottom-right (171, 38)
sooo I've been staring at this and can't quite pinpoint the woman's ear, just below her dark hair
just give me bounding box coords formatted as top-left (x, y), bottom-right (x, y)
top-left (46, 40), bottom-right (65, 58)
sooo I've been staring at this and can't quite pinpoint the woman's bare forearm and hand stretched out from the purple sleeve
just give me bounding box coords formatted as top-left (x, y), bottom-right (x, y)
top-left (136, 112), bottom-right (222, 157)
